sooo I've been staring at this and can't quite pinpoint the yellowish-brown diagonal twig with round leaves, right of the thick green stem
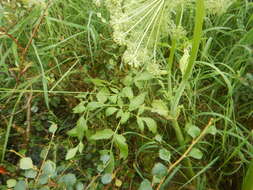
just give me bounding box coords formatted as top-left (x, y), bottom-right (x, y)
top-left (156, 118), bottom-right (213, 190)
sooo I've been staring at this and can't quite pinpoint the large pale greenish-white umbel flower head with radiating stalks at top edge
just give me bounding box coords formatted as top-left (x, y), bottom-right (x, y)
top-left (98, 0), bottom-right (233, 67)
